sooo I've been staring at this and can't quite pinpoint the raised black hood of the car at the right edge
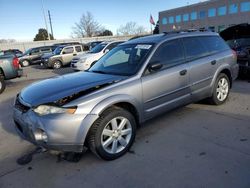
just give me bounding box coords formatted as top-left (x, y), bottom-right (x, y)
top-left (220, 24), bottom-right (250, 41)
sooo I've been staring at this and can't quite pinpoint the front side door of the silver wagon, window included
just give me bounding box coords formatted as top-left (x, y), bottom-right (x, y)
top-left (141, 39), bottom-right (190, 119)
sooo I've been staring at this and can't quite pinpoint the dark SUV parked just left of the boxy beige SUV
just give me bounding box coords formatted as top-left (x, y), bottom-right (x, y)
top-left (19, 45), bottom-right (57, 67)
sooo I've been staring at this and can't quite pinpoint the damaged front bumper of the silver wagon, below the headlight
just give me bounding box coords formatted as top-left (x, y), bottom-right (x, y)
top-left (13, 99), bottom-right (98, 152)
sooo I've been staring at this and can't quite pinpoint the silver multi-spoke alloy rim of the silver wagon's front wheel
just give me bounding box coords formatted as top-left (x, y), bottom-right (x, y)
top-left (101, 117), bottom-right (132, 154)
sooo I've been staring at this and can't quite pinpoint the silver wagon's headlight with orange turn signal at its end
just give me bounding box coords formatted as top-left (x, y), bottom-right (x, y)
top-left (34, 105), bottom-right (77, 115)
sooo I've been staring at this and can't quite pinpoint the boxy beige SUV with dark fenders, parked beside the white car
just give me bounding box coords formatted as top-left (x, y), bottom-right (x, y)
top-left (41, 45), bottom-right (84, 69)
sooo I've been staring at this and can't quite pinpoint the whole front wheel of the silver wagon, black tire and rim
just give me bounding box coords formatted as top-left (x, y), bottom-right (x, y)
top-left (87, 107), bottom-right (136, 160)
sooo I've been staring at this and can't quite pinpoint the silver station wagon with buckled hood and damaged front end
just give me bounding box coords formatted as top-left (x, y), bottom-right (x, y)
top-left (13, 32), bottom-right (238, 160)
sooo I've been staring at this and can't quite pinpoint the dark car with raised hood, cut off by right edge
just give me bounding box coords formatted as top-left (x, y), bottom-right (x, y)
top-left (220, 24), bottom-right (250, 76)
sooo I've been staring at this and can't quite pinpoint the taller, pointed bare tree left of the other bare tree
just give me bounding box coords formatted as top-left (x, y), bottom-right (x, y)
top-left (72, 12), bottom-right (102, 37)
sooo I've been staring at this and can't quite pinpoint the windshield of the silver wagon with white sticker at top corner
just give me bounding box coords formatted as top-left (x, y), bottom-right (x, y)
top-left (89, 44), bottom-right (152, 76)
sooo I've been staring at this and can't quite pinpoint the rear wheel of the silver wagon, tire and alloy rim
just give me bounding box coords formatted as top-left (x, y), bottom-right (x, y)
top-left (209, 73), bottom-right (230, 105)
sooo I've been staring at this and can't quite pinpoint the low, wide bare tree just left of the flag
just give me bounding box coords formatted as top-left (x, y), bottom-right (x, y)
top-left (117, 22), bottom-right (146, 35)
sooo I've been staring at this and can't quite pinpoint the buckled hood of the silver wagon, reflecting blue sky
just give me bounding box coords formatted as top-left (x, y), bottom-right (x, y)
top-left (19, 72), bottom-right (126, 107)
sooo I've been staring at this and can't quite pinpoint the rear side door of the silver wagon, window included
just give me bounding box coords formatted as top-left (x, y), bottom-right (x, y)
top-left (182, 36), bottom-right (216, 100)
